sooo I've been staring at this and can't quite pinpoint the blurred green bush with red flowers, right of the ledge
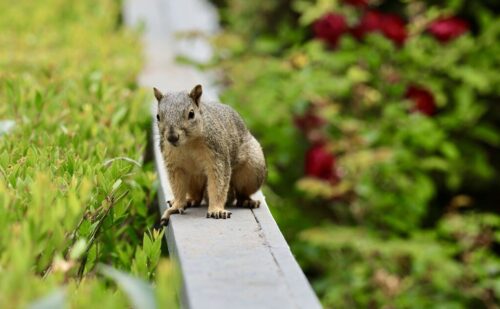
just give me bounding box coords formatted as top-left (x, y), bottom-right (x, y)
top-left (211, 0), bottom-right (500, 308)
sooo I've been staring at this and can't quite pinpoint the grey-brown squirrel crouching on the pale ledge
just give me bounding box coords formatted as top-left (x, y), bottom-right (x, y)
top-left (153, 85), bottom-right (267, 224)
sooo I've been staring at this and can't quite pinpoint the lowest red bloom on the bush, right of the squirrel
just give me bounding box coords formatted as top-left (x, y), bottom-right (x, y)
top-left (306, 143), bottom-right (339, 183)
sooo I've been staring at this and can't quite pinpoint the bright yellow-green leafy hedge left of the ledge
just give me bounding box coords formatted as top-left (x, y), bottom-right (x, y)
top-left (0, 0), bottom-right (175, 308)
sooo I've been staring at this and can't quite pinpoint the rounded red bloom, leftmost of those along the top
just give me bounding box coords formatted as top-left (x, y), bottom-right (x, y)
top-left (313, 13), bottom-right (347, 47)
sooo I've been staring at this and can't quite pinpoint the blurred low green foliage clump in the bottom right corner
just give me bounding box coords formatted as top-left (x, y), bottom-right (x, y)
top-left (294, 215), bottom-right (500, 308)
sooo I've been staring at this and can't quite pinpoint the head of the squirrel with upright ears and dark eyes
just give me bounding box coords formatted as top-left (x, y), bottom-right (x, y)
top-left (153, 85), bottom-right (203, 147)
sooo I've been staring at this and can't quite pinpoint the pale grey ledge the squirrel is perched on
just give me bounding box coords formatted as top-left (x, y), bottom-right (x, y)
top-left (124, 0), bottom-right (321, 309)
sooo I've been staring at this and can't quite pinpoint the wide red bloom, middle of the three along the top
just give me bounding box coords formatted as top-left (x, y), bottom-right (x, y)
top-left (351, 10), bottom-right (408, 45)
